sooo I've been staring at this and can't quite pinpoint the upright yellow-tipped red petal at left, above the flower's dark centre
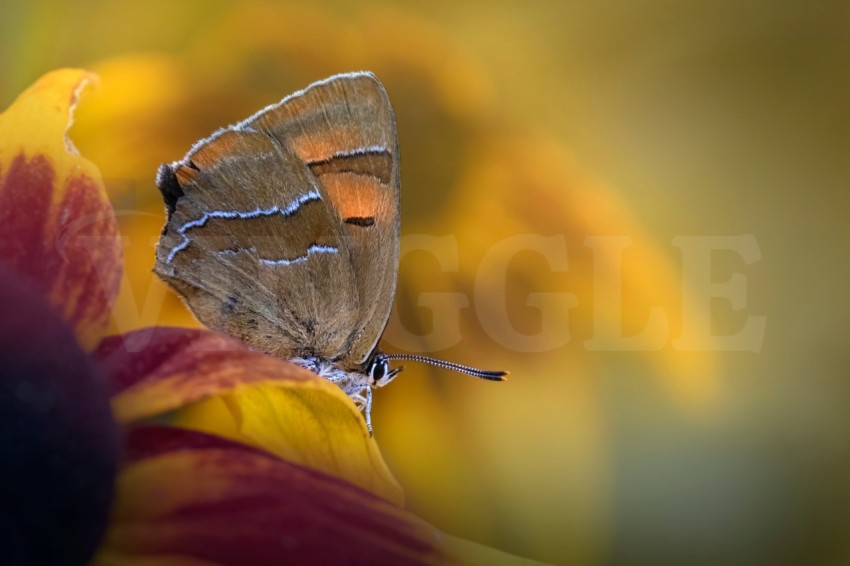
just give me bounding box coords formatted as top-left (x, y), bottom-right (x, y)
top-left (0, 69), bottom-right (121, 348)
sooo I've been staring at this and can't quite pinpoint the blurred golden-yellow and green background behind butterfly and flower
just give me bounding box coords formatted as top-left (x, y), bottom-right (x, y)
top-left (0, 0), bottom-right (850, 564)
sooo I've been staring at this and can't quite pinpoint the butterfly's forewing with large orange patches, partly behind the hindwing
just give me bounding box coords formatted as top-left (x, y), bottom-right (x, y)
top-left (252, 73), bottom-right (400, 368)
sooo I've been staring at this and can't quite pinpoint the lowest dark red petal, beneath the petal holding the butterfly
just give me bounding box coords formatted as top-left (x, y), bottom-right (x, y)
top-left (95, 426), bottom-right (544, 565)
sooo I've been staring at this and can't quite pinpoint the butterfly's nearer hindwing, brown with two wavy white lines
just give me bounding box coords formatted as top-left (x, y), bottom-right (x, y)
top-left (154, 130), bottom-right (358, 357)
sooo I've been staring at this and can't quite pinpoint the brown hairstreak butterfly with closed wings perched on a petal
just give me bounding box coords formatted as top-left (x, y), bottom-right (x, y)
top-left (155, 72), bottom-right (506, 432)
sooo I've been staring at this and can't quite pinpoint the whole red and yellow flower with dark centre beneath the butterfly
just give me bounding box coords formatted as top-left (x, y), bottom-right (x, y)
top-left (0, 69), bottom-right (544, 564)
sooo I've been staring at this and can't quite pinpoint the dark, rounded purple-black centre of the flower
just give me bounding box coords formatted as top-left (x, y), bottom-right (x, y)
top-left (0, 264), bottom-right (119, 564)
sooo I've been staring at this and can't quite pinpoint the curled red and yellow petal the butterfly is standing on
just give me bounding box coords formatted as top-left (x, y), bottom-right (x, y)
top-left (95, 327), bottom-right (404, 505)
